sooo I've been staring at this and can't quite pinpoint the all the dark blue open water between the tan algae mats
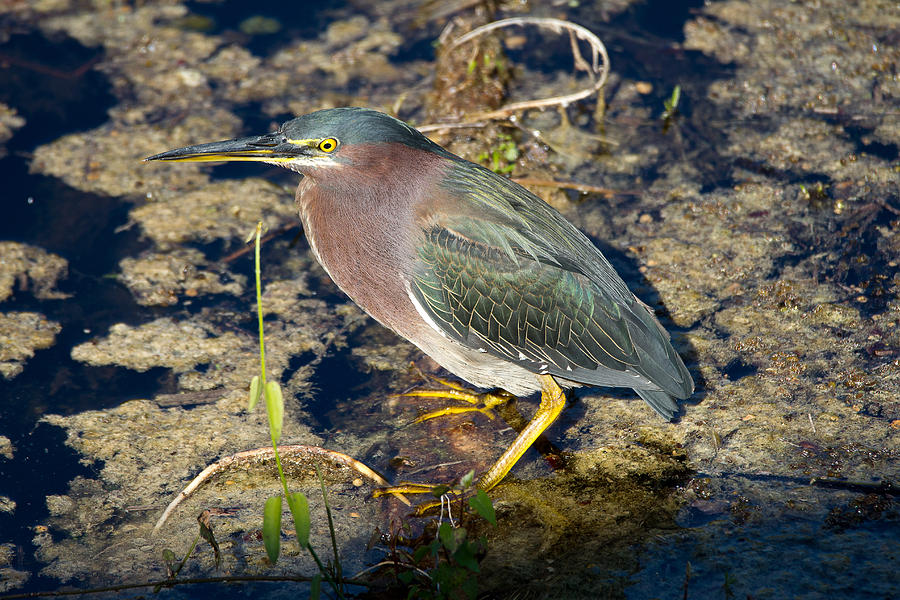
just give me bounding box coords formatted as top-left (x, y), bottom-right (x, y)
top-left (0, 0), bottom-right (898, 598)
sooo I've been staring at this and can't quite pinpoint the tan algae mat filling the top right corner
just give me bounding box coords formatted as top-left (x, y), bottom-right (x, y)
top-left (684, 0), bottom-right (900, 116)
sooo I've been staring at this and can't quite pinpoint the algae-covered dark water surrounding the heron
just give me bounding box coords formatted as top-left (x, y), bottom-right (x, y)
top-left (0, 0), bottom-right (900, 598)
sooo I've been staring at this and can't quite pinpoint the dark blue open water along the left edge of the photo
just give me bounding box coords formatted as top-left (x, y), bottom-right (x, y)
top-left (0, 28), bottom-right (172, 586)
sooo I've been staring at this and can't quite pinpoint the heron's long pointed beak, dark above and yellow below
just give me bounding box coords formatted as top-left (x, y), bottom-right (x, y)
top-left (144, 133), bottom-right (308, 163)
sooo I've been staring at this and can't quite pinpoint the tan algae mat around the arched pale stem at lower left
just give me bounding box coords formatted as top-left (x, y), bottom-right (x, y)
top-left (34, 400), bottom-right (400, 584)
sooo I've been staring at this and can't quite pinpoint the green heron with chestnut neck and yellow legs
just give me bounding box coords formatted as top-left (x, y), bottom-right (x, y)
top-left (147, 108), bottom-right (694, 490)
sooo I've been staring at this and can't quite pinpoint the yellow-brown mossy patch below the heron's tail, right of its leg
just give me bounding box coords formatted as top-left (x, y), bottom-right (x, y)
top-left (481, 434), bottom-right (689, 598)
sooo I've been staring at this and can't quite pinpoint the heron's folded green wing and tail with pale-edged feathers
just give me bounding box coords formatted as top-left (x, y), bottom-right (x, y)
top-left (412, 165), bottom-right (693, 408)
